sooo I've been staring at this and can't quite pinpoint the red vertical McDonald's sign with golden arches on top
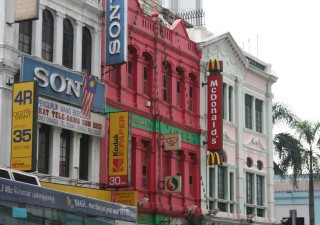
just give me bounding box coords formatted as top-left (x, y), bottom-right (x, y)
top-left (207, 60), bottom-right (223, 151)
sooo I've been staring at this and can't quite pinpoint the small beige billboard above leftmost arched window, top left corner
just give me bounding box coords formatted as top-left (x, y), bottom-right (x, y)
top-left (14, 0), bottom-right (39, 23)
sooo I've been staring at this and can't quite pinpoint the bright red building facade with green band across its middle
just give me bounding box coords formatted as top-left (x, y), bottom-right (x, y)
top-left (100, 0), bottom-right (201, 224)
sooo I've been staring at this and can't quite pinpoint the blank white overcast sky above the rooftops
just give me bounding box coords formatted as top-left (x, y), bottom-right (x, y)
top-left (203, 0), bottom-right (320, 122)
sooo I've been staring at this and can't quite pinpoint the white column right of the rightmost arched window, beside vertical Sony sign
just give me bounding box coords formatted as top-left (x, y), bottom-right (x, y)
top-left (91, 29), bottom-right (101, 78)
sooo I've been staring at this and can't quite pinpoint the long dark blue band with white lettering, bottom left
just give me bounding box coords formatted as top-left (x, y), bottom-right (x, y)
top-left (0, 178), bottom-right (137, 222)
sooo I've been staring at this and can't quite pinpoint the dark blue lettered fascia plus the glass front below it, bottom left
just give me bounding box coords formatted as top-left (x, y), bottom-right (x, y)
top-left (0, 178), bottom-right (137, 225)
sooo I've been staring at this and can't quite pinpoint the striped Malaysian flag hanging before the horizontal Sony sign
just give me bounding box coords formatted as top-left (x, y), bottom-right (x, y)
top-left (82, 73), bottom-right (97, 117)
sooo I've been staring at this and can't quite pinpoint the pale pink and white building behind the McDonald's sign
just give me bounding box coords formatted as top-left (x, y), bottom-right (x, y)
top-left (188, 27), bottom-right (277, 224)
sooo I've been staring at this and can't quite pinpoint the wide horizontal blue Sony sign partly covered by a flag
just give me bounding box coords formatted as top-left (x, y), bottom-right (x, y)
top-left (20, 56), bottom-right (105, 112)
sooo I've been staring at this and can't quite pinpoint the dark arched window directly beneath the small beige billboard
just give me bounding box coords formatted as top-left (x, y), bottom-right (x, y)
top-left (18, 20), bottom-right (32, 55)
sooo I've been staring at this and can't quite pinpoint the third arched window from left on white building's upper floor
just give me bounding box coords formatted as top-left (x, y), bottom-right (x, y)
top-left (62, 19), bottom-right (73, 69)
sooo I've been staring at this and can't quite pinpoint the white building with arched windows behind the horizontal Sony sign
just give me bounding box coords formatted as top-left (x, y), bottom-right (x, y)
top-left (0, 0), bottom-right (102, 187)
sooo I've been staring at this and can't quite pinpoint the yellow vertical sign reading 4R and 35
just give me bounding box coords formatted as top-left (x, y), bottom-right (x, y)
top-left (11, 81), bottom-right (38, 171)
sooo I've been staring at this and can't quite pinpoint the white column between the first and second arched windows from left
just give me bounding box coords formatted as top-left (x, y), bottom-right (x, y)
top-left (31, 5), bottom-right (44, 58)
